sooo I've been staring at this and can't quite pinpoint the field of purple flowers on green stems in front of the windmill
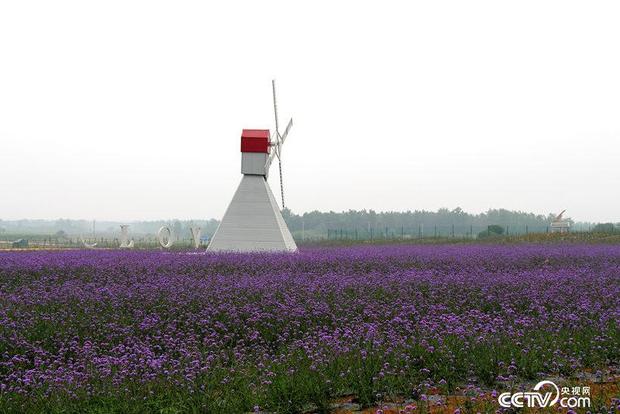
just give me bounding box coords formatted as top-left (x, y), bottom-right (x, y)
top-left (0, 245), bottom-right (620, 413)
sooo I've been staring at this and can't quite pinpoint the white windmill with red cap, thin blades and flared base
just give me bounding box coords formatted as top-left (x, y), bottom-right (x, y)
top-left (207, 81), bottom-right (297, 252)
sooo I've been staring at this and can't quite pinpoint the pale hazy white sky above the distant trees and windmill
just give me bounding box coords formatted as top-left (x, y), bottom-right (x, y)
top-left (0, 1), bottom-right (620, 221)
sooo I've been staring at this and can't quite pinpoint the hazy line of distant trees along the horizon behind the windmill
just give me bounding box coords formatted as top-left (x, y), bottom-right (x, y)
top-left (0, 207), bottom-right (620, 239)
